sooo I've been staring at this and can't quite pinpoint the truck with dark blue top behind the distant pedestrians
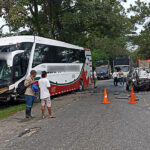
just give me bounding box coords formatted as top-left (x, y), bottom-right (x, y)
top-left (113, 58), bottom-right (130, 78)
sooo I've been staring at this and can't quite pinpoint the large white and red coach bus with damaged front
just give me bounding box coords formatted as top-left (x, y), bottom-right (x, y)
top-left (0, 36), bottom-right (92, 100)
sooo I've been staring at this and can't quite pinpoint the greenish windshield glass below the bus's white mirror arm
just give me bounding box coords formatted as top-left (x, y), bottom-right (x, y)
top-left (0, 60), bottom-right (11, 80)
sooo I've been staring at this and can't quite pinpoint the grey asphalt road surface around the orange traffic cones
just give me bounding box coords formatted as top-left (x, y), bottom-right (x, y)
top-left (0, 80), bottom-right (150, 150)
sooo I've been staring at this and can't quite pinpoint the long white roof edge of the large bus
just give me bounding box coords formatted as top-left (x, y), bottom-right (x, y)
top-left (0, 35), bottom-right (84, 50)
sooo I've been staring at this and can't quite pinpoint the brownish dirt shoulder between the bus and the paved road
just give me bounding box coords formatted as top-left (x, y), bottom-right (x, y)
top-left (0, 87), bottom-right (93, 143)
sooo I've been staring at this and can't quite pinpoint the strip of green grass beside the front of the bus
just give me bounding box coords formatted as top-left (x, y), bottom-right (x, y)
top-left (0, 104), bottom-right (25, 120)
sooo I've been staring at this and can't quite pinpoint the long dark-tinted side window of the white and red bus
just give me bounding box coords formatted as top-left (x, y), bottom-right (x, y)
top-left (33, 44), bottom-right (86, 67)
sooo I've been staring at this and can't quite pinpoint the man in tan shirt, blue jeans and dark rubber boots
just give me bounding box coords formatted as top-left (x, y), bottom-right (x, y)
top-left (24, 70), bottom-right (36, 119)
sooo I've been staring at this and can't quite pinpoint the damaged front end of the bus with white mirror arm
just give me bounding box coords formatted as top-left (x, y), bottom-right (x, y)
top-left (0, 37), bottom-right (33, 101)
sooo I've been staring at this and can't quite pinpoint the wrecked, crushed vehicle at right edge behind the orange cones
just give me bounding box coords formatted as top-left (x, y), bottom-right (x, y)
top-left (126, 68), bottom-right (150, 91)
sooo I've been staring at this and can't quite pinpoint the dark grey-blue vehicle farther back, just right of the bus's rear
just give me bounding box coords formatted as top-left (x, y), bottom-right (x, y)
top-left (96, 65), bottom-right (111, 80)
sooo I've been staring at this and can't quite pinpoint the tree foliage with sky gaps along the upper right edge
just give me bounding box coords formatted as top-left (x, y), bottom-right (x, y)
top-left (128, 0), bottom-right (150, 59)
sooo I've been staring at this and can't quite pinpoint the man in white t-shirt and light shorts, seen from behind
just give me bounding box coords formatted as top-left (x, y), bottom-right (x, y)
top-left (39, 71), bottom-right (54, 119)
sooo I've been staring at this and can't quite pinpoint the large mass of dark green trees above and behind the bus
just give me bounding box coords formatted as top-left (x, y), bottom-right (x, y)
top-left (0, 0), bottom-right (133, 65)
